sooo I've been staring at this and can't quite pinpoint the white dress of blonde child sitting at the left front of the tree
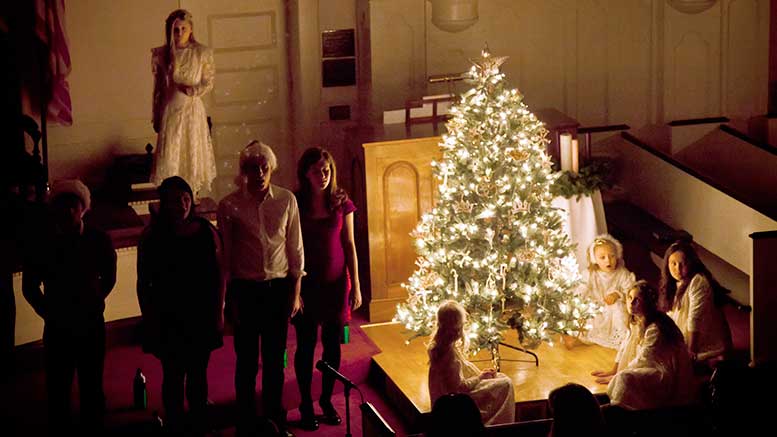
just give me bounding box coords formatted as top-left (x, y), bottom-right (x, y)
top-left (429, 349), bottom-right (515, 425)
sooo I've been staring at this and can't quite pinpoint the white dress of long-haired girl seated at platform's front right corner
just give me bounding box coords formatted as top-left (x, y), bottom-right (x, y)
top-left (607, 318), bottom-right (694, 410)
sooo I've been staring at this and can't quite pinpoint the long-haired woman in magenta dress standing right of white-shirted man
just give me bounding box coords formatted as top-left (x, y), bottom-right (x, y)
top-left (293, 147), bottom-right (361, 430)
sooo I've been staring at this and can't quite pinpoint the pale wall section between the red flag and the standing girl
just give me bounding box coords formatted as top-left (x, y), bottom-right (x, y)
top-left (48, 0), bottom-right (178, 186)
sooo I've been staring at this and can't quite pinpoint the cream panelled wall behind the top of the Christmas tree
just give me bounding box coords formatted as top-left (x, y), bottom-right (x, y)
top-left (370, 0), bottom-right (769, 127)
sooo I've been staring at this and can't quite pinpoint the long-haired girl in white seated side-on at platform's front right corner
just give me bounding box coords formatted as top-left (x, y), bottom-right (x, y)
top-left (607, 281), bottom-right (693, 410)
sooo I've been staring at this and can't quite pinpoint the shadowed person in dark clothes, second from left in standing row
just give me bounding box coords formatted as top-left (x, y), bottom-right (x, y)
top-left (137, 176), bottom-right (224, 434)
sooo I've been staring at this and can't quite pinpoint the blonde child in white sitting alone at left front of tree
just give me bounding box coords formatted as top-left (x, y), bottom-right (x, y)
top-left (428, 300), bottom-right (515, 425)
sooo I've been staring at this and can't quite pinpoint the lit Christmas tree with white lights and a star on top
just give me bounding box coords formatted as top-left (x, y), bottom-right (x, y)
top-left (395, 49), bottom-right (598, 357)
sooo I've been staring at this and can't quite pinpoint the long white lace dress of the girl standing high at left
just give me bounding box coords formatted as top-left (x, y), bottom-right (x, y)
top-left (151, 42), bottom-right (216, 195)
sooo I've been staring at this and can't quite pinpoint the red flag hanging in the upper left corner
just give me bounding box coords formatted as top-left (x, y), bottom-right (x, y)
top-left (35, 0), bottom-right (73, 126)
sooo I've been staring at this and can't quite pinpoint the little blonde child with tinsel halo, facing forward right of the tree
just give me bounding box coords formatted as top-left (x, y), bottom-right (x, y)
top-left (581, 234), bottom-right (636, 349)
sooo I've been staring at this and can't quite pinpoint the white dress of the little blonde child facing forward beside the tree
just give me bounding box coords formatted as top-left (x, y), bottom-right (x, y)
top-left (580, 267), bottom-right (636, 349)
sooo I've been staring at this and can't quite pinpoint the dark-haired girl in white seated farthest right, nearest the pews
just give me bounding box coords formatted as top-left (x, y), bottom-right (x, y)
top-left (661, 241), bottom-right (731, 361)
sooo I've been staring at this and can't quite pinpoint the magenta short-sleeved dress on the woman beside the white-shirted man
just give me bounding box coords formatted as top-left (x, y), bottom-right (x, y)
top-left (300, 199), bottom-right (356, 323)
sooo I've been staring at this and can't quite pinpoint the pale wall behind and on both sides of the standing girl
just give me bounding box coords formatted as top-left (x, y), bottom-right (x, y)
top-left (49, 0), bottom-right (294, 198)
